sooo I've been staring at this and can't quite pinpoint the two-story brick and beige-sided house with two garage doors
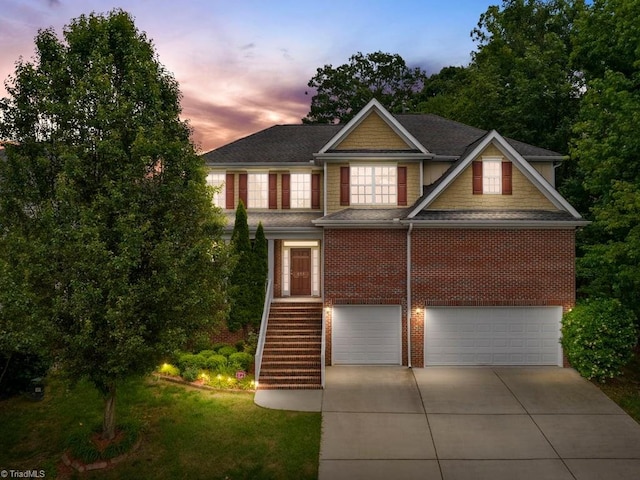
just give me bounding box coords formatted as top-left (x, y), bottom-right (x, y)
top-left (204, 100), bottom-right (586, 386)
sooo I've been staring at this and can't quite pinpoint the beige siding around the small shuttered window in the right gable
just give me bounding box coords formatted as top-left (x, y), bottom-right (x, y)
top-left (429, 145), bottom-right (556, 210)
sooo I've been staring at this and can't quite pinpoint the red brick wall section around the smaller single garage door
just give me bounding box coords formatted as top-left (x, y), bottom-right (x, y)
top-left (324, 229), bottom-right (407, 364)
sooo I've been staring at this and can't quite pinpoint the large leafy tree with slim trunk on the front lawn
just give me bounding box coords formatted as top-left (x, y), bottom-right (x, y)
top-left (0, 10), bottom-right (227, 439)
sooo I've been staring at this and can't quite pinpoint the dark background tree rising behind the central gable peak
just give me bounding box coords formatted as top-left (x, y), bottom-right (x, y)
top-left (302, 52), bottom-right (426, 123)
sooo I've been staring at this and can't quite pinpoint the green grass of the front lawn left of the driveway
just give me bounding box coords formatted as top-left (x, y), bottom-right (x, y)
top-left (0, 378), bottom-right (321, 480)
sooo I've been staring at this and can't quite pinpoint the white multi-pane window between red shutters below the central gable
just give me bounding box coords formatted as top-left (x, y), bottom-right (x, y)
top-left (350, 165), bottom-right (398, 205)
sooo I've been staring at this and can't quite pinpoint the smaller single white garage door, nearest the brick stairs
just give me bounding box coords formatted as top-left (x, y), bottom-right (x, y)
top-left (331, 305), bottom-right (402, 365)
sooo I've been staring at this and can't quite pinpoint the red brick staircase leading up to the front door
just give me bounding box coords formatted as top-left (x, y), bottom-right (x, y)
top-left (258, 302), bottom-right (322, 390)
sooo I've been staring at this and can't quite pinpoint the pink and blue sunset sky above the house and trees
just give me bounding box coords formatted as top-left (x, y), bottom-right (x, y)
top-left (0, 0), bottom-right (490, 151)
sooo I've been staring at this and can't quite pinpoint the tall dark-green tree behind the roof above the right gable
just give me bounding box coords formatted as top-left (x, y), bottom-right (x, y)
top-left (420, 0), bottom-right (583, 153)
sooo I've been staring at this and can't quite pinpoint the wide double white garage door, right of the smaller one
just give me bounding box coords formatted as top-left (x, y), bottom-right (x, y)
top-left (425, 307), bottom-right (562, 366)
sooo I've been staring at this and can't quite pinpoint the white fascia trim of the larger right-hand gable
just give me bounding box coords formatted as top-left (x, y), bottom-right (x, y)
top-left (408, 130), bottom-right (582, 219)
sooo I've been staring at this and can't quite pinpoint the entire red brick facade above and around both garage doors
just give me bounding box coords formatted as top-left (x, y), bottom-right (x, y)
top-left (324, 228), bottom-right (575, 367)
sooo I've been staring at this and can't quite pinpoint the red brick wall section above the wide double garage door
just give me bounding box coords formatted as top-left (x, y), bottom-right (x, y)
top-left (411, 229), bottom-right (575, 367)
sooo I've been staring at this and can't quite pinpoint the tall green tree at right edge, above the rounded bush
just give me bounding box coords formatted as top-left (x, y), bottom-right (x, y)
top-left (571, 0), bottom-right (640, 317)
